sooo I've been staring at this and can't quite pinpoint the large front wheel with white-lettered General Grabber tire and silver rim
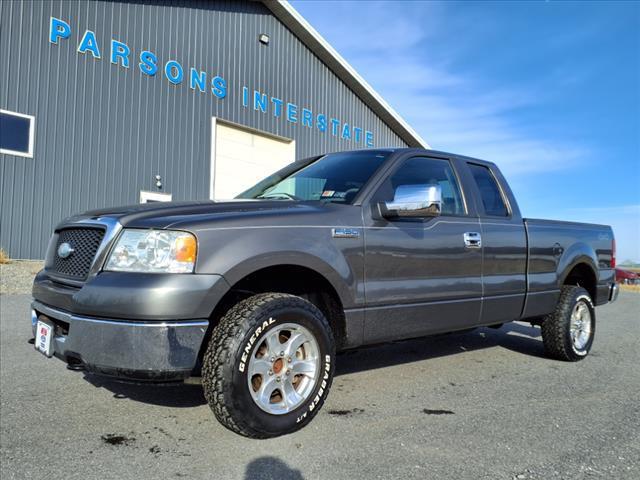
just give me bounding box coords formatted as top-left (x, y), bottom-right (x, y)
top-left (202, 293), bottom-right (335, 438)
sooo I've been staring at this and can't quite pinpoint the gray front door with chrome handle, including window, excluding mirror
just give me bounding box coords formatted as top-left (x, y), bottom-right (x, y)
top-left (363, 156), bottom-right (482, 343)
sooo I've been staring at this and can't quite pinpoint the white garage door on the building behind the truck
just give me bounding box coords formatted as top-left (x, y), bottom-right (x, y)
top-left (211, 119), bottom-right (296, 200)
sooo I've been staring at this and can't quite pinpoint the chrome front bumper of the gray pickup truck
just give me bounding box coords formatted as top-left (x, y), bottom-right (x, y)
top-left (31, 301), bottom-right (209, 382)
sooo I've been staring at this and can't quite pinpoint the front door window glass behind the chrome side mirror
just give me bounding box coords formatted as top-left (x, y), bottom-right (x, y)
top-left (374, 157), bottom-right (465, 215)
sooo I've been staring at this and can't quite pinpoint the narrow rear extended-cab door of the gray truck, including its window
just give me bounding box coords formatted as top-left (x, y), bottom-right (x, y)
top-left (464, 159), bottom-right (527, 325)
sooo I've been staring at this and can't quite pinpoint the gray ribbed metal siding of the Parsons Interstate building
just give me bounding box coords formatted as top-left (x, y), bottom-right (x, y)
top-left (0, 0), bottom-right (406, 258)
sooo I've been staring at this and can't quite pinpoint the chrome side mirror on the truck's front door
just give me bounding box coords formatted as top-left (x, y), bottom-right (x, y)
top-left (378, 185), bottom-right (442, 218)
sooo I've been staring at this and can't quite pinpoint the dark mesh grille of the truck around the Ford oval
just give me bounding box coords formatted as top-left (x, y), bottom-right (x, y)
top-left (51, 227), bottom-right (105, 280)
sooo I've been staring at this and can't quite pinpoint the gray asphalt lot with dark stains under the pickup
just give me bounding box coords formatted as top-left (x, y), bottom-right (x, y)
top-left (0, 292), bottom-right (640, 480)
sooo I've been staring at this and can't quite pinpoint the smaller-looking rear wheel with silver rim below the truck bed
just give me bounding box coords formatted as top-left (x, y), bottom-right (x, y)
top-left (542, 285), bottom-right (596, 362)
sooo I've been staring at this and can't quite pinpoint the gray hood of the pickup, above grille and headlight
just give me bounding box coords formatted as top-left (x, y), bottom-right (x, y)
top-left (63, 199), bottom-right (335, 230)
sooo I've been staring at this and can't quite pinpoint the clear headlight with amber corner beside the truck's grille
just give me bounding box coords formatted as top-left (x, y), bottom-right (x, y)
top-left (104, 229), bottom-right (196, 273)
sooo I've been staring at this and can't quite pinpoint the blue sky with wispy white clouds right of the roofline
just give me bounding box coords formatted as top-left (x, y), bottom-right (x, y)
top-left (291, 0), bottom-right (640, 263)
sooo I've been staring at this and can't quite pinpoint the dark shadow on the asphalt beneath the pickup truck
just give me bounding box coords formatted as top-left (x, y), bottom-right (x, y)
top-left (79, 323), bottom-right (544, 408)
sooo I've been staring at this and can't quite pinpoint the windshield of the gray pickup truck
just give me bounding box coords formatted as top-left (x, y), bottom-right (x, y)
top-left (236, 150), bottom-right (391, 204)
